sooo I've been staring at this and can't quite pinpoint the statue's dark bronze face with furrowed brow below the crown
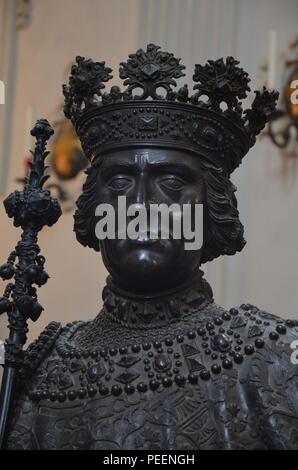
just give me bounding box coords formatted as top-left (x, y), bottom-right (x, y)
top-left (97, 148), bottom-right (203, 292)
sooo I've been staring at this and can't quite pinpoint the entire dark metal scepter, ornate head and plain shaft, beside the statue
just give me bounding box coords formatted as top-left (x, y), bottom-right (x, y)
top-left (0, 119), bottom-right (61, 448)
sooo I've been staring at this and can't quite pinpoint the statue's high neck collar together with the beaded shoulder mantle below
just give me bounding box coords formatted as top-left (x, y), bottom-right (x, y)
top-left (23, 276), bottom-right (291, 402)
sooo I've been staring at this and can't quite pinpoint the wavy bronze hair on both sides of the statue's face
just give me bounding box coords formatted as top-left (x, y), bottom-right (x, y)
top-left (74, 157), bottom-right (245, 263)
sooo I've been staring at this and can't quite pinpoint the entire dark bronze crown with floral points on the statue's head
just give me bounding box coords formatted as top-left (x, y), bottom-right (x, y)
top-left (63, 44), bottom-right (278, 173)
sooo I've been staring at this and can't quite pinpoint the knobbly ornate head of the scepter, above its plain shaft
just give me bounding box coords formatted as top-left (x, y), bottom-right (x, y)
top-left (0, 119), bottom-right (61, 328)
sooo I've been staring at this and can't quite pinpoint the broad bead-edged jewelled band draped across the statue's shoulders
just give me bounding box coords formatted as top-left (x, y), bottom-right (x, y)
top-left (28, 304), bottom-right (297, 402)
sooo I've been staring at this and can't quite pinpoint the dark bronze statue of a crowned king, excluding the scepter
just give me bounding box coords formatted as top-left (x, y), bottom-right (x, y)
top-left (1, 44), bottom-right (298, 450)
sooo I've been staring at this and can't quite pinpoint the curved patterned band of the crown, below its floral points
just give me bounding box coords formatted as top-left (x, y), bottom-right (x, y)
top-left (76, 101), bottom-right (249, 173)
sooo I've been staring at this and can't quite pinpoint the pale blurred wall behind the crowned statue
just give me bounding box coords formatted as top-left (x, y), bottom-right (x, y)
top-left (0, 0), bottom-right (298, 356)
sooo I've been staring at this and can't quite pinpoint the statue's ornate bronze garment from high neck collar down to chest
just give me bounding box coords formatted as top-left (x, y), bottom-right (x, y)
top-left (10, 279), bottom-right (297, 450)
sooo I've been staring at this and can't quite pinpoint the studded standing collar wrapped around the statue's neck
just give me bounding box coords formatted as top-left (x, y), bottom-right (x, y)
top-left (103, 271), bottom-right (213, 327)
